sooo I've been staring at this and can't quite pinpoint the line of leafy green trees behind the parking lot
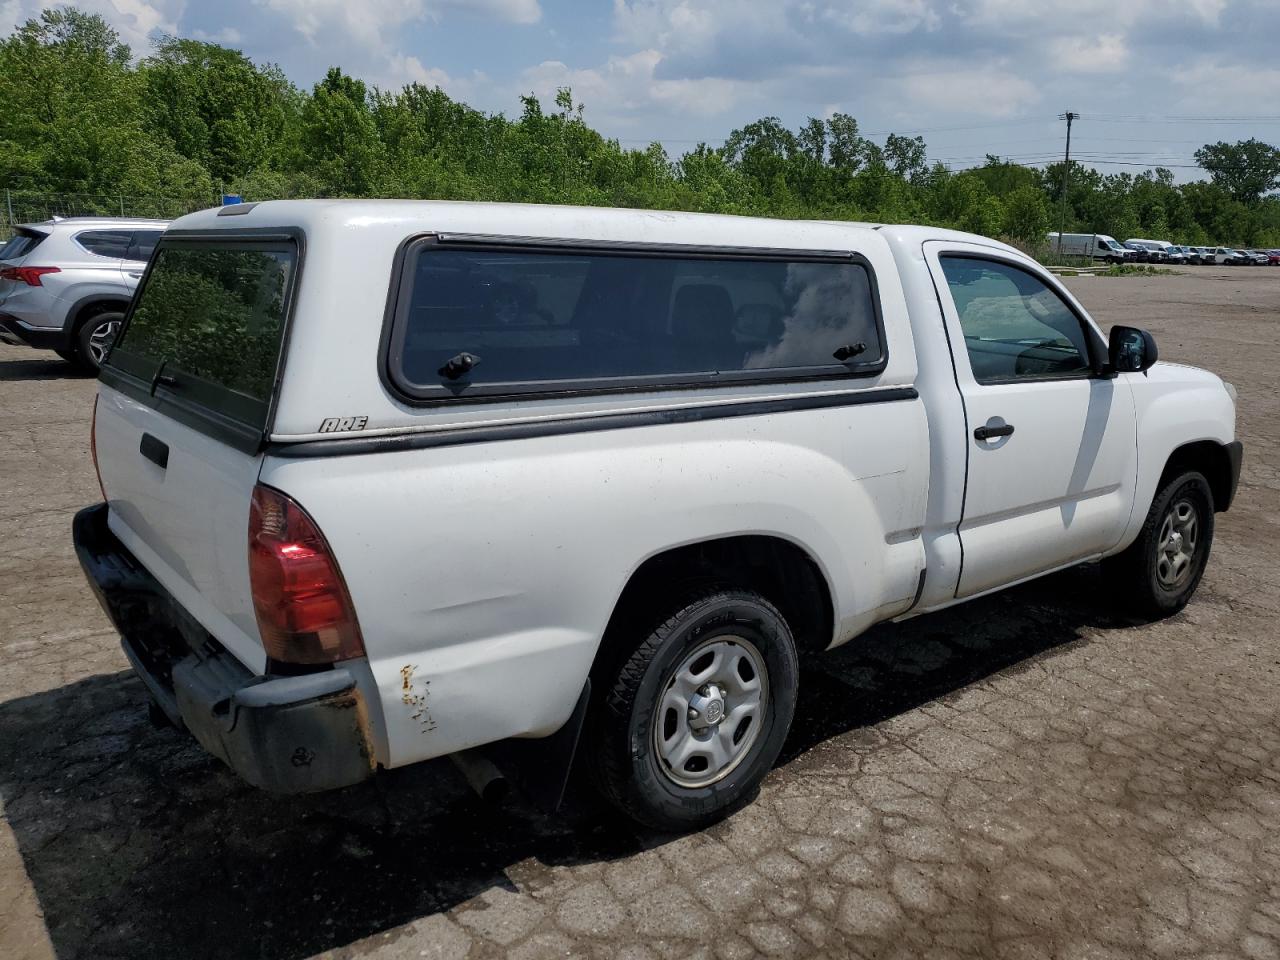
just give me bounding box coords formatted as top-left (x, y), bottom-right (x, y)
top-left (0, 8), bottom-right (1280, 247)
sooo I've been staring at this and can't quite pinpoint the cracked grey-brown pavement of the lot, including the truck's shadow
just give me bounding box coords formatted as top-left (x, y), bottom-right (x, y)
top-left (0, 268), bottom-right (1280, 960)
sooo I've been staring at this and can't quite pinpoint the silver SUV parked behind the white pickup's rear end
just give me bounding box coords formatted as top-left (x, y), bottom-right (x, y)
top-left (0, 216), bottom-right (169, 372)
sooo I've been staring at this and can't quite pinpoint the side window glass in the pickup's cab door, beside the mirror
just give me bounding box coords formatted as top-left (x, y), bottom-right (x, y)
top-left (941, 256), bottom-right (1092, 384)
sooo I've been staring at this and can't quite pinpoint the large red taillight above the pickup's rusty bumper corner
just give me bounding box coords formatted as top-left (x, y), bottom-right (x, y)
top-left (248, 484), bottom-right (365, 663)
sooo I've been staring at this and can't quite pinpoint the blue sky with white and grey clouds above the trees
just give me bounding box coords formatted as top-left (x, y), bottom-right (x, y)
top-left (0, 0), bottom-right (1280, 179)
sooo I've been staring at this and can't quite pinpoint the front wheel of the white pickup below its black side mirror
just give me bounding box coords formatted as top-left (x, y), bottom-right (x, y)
top-left (1103, 470), bottom-right (1213, 620)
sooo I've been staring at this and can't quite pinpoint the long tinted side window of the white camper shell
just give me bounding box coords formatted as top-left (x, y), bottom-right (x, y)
top-left (385, 237), bottom-right (887, 403)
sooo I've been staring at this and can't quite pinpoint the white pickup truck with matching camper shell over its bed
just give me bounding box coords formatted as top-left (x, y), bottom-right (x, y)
top-left (74, 201), bottom-right (1242, 829)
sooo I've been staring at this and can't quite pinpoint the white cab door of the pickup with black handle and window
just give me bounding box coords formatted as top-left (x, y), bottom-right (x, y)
top-left (924, 241), bottom-right (1137, 598)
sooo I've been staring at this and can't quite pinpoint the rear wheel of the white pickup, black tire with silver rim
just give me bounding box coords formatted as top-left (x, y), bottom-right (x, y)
top-left (588, 589), bottom-right (799, 833)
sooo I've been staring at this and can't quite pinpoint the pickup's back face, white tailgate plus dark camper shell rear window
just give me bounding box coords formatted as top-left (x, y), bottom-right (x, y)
top-left (95, 234), bottom-right (297, 672)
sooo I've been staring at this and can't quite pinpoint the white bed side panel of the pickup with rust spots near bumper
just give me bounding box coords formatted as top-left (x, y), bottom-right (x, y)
top-left (262, 399), bottom-right (927, 765)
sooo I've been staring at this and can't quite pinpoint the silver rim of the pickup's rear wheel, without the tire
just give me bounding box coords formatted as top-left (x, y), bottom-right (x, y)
top-left (653, 636), bottom-right (769, 788)
